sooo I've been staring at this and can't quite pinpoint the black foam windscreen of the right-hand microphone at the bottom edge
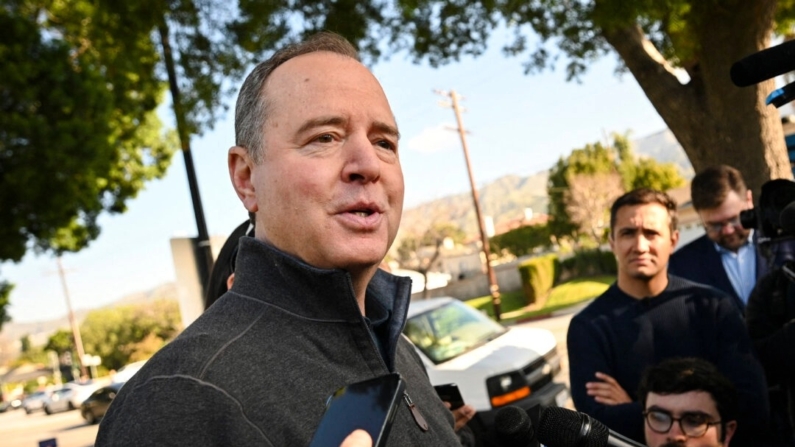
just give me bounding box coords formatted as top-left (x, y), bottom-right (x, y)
top-left (536, 407), bottom-right (610, 447)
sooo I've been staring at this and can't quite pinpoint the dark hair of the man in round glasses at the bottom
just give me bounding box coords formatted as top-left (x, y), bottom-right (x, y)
top-left (638, 357), bottom-right (738, 441)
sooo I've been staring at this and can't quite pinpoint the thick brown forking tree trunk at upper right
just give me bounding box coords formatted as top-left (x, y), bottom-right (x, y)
top-left (604, 0), bottom-right (792, 198)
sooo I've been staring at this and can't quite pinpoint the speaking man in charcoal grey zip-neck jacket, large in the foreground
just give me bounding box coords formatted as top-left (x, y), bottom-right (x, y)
top-left (95, 33), bottom-right (459, 447)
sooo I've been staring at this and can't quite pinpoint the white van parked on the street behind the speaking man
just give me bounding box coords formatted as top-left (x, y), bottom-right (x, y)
top-left (404, 297), bottom-right (569, 431)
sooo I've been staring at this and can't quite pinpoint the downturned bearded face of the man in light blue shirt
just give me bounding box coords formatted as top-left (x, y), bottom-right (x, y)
top-left (698, 191), bottom-right (753, 251)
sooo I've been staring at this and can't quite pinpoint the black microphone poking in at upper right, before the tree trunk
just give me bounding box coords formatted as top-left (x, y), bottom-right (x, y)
top-left (729, 40), bottom-right (795, 87)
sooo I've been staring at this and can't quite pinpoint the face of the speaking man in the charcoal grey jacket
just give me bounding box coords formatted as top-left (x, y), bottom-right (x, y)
top-left (238, 52), bottom-right (403, 272)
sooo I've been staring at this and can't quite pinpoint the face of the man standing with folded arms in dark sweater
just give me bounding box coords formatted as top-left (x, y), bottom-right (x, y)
top-left (610, 203), bottom-right (679, 282)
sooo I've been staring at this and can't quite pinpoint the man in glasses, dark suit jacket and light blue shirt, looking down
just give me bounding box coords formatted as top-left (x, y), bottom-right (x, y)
top-left (668, 165), bottom-right (766, 311)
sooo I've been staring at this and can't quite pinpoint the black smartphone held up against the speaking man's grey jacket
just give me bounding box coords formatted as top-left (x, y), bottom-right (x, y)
top-left (309, 374), bottom-right (406, 447)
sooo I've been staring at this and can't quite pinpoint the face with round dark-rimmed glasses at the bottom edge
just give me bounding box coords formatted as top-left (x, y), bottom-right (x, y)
top-left (644, 391), bottom-right (737, 447)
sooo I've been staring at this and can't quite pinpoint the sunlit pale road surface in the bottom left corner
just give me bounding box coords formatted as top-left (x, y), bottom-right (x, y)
top-left (0, 410), bottom-right (98, 447)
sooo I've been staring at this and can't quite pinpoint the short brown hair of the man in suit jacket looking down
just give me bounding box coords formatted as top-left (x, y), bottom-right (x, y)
top-left (690, 165), bottom-right (748, 211)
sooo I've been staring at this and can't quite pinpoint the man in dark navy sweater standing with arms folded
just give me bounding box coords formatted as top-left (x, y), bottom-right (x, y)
top-left (567, 189), bottom-right (768, 446)
